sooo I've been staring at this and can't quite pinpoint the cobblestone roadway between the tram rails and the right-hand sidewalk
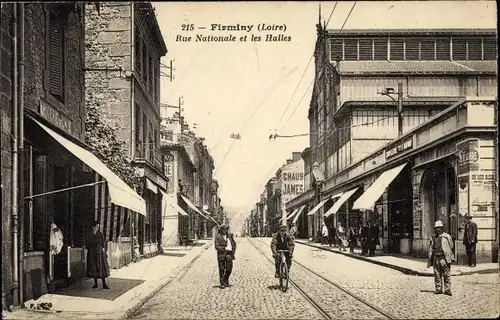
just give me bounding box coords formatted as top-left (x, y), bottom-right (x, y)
top-left (252, 238), bottom-right (500, 319)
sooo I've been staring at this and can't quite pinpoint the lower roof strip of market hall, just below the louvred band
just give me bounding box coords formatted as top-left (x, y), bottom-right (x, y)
top-left (339, 60), bottom-right (498, 75)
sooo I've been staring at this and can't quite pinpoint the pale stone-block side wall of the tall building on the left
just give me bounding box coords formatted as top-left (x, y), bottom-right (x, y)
top-left (85, 2), bottom-right (132, 151)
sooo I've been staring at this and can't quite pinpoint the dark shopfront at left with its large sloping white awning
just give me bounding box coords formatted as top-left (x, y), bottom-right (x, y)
top-left (20, 115), bottom-right (146, 300)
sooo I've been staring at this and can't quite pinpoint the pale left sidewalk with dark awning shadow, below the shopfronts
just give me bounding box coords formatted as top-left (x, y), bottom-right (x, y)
top-left (3, 239), bottom-right (212, 320)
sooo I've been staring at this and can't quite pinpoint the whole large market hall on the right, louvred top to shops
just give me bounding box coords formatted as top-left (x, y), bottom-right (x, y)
top-left (288, 25), bottom-right (498, 261)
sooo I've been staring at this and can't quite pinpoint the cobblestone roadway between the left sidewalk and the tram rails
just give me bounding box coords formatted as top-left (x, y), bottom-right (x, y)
top-left (133, 239), bottom-right (322, 319)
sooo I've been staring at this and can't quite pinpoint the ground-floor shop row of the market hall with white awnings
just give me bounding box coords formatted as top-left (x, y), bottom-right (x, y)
top-left (290, 97), bottom-right (499, 263)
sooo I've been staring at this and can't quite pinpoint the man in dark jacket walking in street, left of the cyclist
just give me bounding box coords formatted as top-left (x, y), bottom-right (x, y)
top-left (215, 225), bottom-right (236, 289)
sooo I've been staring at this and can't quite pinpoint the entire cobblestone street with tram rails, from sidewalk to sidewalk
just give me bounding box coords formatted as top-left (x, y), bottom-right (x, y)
top-left (133, 239), bottom-right (499, 319)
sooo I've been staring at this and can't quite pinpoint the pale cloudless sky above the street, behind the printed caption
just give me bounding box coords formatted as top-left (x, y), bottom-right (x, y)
top-left (153, 1), bottom-right (496, 231)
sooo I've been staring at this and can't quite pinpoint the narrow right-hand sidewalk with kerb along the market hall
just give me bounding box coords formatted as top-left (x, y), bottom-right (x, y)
top-left (295, 239), bottom-right (499, 277)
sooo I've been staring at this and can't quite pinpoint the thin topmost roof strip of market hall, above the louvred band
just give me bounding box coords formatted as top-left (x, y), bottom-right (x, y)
top-left (327, 28), bottom-right (497, 36)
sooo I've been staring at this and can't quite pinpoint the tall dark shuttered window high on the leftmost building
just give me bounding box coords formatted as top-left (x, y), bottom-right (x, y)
top-left (48, 12), bottom-right (65, 102)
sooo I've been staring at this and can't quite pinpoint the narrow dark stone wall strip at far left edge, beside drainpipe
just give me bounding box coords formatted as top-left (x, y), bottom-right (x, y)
top-left (0, 4), bottom-right (13, 304)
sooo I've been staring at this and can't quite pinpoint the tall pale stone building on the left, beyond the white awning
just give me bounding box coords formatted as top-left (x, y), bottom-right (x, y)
top-left (85, 2), bottom-right (167, 267)
